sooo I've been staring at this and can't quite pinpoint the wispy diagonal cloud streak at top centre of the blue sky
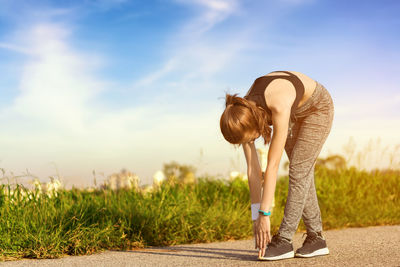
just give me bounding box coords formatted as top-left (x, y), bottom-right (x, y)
top-left (133, 0), bottom-right (244, 93)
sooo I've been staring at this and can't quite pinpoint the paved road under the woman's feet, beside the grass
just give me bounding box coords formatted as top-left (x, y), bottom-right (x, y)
top-left (0, 225), bottom-right (400, 267)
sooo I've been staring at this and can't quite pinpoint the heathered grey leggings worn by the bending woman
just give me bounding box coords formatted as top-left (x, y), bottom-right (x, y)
top-left (279, 82), bottom-right (334, 240)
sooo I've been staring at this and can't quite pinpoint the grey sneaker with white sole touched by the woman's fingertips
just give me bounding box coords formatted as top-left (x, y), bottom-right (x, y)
top-left (258, 233), bottom-right (294, 261)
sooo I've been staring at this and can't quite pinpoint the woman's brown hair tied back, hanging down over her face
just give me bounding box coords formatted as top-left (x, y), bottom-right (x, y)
top-left (219, 93), bottom-right (272, 148)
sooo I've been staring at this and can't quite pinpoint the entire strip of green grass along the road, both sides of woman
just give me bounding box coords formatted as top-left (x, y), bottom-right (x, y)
top-left (0, 167), bottom-right (400, 260)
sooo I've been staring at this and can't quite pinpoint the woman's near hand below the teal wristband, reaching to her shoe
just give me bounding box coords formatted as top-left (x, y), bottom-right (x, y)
top-left (253, 214), bottom-right (271, 258)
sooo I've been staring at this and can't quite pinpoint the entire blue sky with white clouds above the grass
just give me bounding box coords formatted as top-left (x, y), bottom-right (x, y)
top-left (0, 0), bottom-right (400, 187)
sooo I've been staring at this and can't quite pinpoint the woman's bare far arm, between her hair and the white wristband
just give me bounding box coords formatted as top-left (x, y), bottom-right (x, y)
top-left (242, 142), bottom-right (262, 204)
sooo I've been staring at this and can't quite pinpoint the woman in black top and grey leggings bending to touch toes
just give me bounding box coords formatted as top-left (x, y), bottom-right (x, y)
top-left (220, 71), bottom-right (334, 260)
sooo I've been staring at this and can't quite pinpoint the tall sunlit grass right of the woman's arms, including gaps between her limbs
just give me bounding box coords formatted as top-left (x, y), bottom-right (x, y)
top-left (273, 167), bottom-right (400, 230)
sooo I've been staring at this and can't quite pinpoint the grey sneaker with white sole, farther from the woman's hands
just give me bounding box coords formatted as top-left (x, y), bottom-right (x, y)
top-left (296, 232), bottom-right (329, 258)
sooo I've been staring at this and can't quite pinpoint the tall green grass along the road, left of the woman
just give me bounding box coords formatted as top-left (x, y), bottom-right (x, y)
top-left (0, 178), bottom-right (251, 259)
